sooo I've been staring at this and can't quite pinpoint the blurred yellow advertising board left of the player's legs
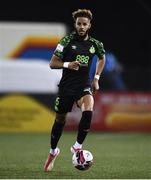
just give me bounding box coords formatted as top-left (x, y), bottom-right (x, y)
top-left (0, 94), bottom-right (55, 132)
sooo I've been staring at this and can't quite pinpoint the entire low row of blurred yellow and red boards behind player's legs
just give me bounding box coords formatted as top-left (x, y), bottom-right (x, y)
top-left (0, 93), bottom-right (151, 132)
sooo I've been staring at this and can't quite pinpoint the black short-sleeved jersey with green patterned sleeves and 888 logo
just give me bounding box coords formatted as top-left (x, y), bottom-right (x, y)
top-left (54, 34), bottom-right (105, 91)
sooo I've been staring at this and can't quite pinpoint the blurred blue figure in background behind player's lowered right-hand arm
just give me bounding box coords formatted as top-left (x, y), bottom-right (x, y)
top-left (90, 51), bottom-right (126, 91)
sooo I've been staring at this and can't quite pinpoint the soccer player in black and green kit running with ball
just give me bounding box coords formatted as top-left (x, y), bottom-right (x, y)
top-left (44, 9), bottom-right (105, 172)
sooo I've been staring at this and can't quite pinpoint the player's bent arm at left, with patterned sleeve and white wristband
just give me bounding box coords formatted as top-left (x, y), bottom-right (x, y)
top-left (49, 35), bottom-right (80, 70)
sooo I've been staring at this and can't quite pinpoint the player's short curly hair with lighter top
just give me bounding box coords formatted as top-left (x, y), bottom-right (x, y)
top-left (72, 9), bottom-right (92, 21)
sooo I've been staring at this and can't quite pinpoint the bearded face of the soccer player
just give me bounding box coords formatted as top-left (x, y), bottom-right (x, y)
top-left (75, 17), bottom-right (91, 36)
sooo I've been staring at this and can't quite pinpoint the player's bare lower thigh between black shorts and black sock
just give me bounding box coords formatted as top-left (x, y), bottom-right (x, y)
top-left (78, 94), bottom-right (94, 111)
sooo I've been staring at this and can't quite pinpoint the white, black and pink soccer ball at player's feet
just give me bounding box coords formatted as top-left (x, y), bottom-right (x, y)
top-left (72, 150), bottom-right (93, 171)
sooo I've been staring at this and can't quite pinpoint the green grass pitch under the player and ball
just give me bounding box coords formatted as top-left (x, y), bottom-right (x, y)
top-left (0, 132), bottom-right (151, 179)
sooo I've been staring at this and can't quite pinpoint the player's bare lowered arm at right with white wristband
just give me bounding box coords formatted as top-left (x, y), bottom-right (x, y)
top-left (92, 55), bottom-right (105, 93)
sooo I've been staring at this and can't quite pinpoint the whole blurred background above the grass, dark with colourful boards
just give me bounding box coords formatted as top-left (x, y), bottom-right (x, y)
top-left (0, 0), bottom-right (151, 132)
